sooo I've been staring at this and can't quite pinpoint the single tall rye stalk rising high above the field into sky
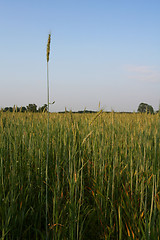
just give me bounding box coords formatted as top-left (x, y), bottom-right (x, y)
top-left (46, 34), bottom-right (51, 239)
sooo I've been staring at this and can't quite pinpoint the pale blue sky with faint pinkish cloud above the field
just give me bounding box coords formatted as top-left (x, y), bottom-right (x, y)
top-left (0, 0), bottom-right (160, 111)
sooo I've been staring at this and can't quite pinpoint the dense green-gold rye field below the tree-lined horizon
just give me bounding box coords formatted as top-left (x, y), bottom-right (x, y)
top-left (0, 112), bottom-right (160, 240)
